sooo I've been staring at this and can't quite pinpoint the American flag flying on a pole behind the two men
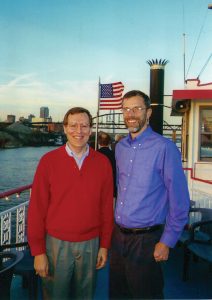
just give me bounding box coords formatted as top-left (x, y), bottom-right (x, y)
top-left (99, 82), bottom-right (124, 110)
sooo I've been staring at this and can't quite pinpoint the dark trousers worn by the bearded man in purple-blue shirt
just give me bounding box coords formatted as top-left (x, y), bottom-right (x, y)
top-left (109, 226), bottom-right (164, 299)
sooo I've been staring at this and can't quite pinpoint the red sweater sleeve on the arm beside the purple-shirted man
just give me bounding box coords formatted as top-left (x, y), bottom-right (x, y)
top-left (100, 160), bottom-right (113, 248)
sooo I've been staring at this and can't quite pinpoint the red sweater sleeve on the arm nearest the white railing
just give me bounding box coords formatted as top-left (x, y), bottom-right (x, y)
top-left (27, 157), bottom-right (50, 255)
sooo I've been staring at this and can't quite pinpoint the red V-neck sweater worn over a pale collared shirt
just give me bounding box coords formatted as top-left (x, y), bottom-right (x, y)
top-left (28, 146), bottom-right (113, 255)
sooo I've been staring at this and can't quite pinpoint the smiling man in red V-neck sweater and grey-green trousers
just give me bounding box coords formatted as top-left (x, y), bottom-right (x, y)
top-left (28, 107), bottom-right (113, 299)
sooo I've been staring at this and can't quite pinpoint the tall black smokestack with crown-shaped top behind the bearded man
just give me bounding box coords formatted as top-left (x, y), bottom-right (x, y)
top-left (147, 59), bottom-right (168, 135)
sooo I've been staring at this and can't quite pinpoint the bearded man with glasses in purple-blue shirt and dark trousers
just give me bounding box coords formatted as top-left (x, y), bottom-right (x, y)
top-left (110, 90), bottom-right (189, 299)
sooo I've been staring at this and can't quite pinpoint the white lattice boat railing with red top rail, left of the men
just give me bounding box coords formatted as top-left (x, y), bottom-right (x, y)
top-left (0, 184), bottom-right (32, 245)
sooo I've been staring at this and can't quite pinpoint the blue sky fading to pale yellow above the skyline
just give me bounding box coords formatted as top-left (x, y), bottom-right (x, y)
top-left (0, 0), bottom-right (212, 122)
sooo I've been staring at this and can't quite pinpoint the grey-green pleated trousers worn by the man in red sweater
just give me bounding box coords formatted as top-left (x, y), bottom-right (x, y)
top-left (42, 235), bottom-right (99, 300)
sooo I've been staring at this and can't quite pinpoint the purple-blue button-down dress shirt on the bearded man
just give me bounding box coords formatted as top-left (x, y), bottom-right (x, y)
top-left (115, 127), bottom-right (190, 247)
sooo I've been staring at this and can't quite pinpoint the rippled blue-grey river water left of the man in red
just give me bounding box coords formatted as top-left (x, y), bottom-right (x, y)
top-left (0, 146), bottom-right (56, 212)
